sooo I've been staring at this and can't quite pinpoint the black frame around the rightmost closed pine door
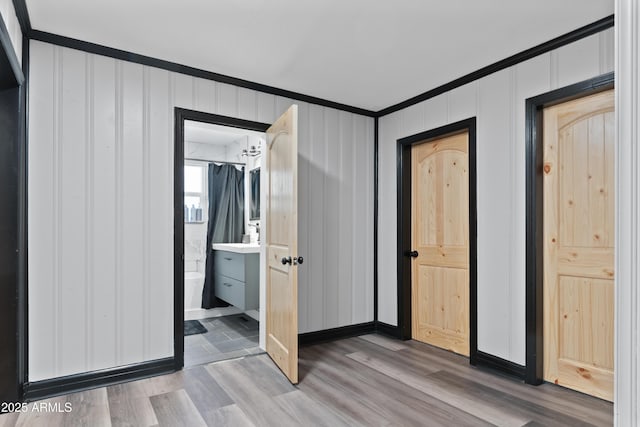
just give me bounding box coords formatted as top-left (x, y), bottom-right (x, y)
top-left (525, 73), bottom-right (614, 385)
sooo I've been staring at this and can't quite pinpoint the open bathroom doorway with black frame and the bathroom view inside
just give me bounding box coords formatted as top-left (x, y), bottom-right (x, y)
top-left (174, 108), bottom-right (269, 369)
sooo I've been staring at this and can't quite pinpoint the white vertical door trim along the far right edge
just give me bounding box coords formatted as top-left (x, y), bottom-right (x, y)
top-left (614, 0), bottom-right (640, 426)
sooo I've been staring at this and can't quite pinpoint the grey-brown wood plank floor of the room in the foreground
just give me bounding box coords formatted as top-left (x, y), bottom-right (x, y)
top-left (0, 335), bottom-right (613, 427)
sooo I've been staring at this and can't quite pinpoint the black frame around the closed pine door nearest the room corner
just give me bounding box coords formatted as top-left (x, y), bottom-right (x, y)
top-left (397, 117), bottom-right (478, 364)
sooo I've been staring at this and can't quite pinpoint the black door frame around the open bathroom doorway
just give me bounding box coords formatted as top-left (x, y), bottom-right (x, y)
top-left (173, 107), bottom-right (271, 371)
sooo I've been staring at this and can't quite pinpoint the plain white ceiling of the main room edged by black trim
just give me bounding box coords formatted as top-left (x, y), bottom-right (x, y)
top-left (26, 0), bottom-right (614, 111)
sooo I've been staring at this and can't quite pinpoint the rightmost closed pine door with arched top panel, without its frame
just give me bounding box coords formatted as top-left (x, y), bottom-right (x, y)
top-left (543, 90), bottom-right (615, 401)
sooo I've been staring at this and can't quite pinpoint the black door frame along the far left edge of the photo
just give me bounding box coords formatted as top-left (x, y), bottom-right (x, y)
top-left (0, 15), bottom-right (29, 402)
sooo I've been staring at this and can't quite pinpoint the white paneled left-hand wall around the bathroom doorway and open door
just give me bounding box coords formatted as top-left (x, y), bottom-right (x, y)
top-left (29, 41), bottom-right (374, 381)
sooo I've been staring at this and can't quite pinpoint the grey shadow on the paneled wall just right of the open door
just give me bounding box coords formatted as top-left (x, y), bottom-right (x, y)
top-left (298, 153), bottom-right (355, 333)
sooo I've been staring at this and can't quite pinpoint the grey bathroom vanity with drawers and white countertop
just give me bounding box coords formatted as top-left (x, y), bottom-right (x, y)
top-left (212, 243), bottom-right (260, 310)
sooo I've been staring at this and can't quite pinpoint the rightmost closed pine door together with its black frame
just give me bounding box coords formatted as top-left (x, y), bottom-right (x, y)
top-left (525, 73), bottom-right (614, 400)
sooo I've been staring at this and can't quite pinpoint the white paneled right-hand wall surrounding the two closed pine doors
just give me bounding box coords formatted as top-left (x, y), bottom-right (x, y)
top-left (378, 29), bottom-right (614, 364)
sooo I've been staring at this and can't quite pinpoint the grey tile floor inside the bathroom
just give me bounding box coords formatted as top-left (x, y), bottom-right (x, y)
top-left (184, 314), bottom-right (263, 367)
